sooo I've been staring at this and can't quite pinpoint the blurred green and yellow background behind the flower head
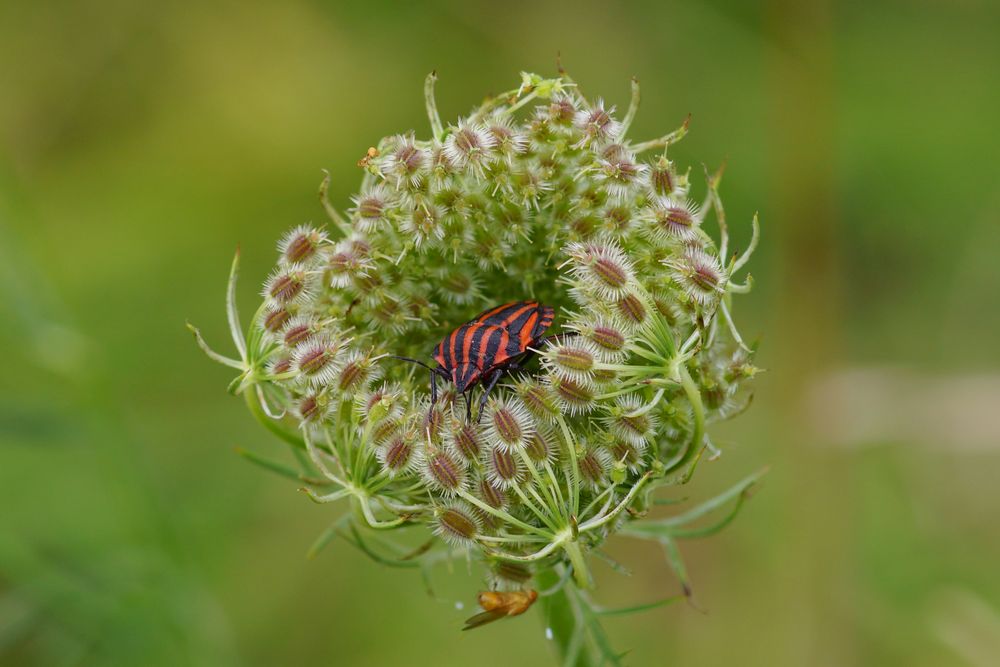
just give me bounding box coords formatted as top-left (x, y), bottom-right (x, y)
top-left (0, 0), bottom-right (1000, 666)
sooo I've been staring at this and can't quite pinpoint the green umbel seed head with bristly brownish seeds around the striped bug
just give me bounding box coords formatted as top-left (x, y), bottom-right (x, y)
top-left (189, 74), bottom-right (758, 656)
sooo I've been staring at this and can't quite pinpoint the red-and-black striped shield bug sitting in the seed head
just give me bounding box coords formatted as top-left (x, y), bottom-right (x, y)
top-left (395, 301), bottom-right (555, 419)
